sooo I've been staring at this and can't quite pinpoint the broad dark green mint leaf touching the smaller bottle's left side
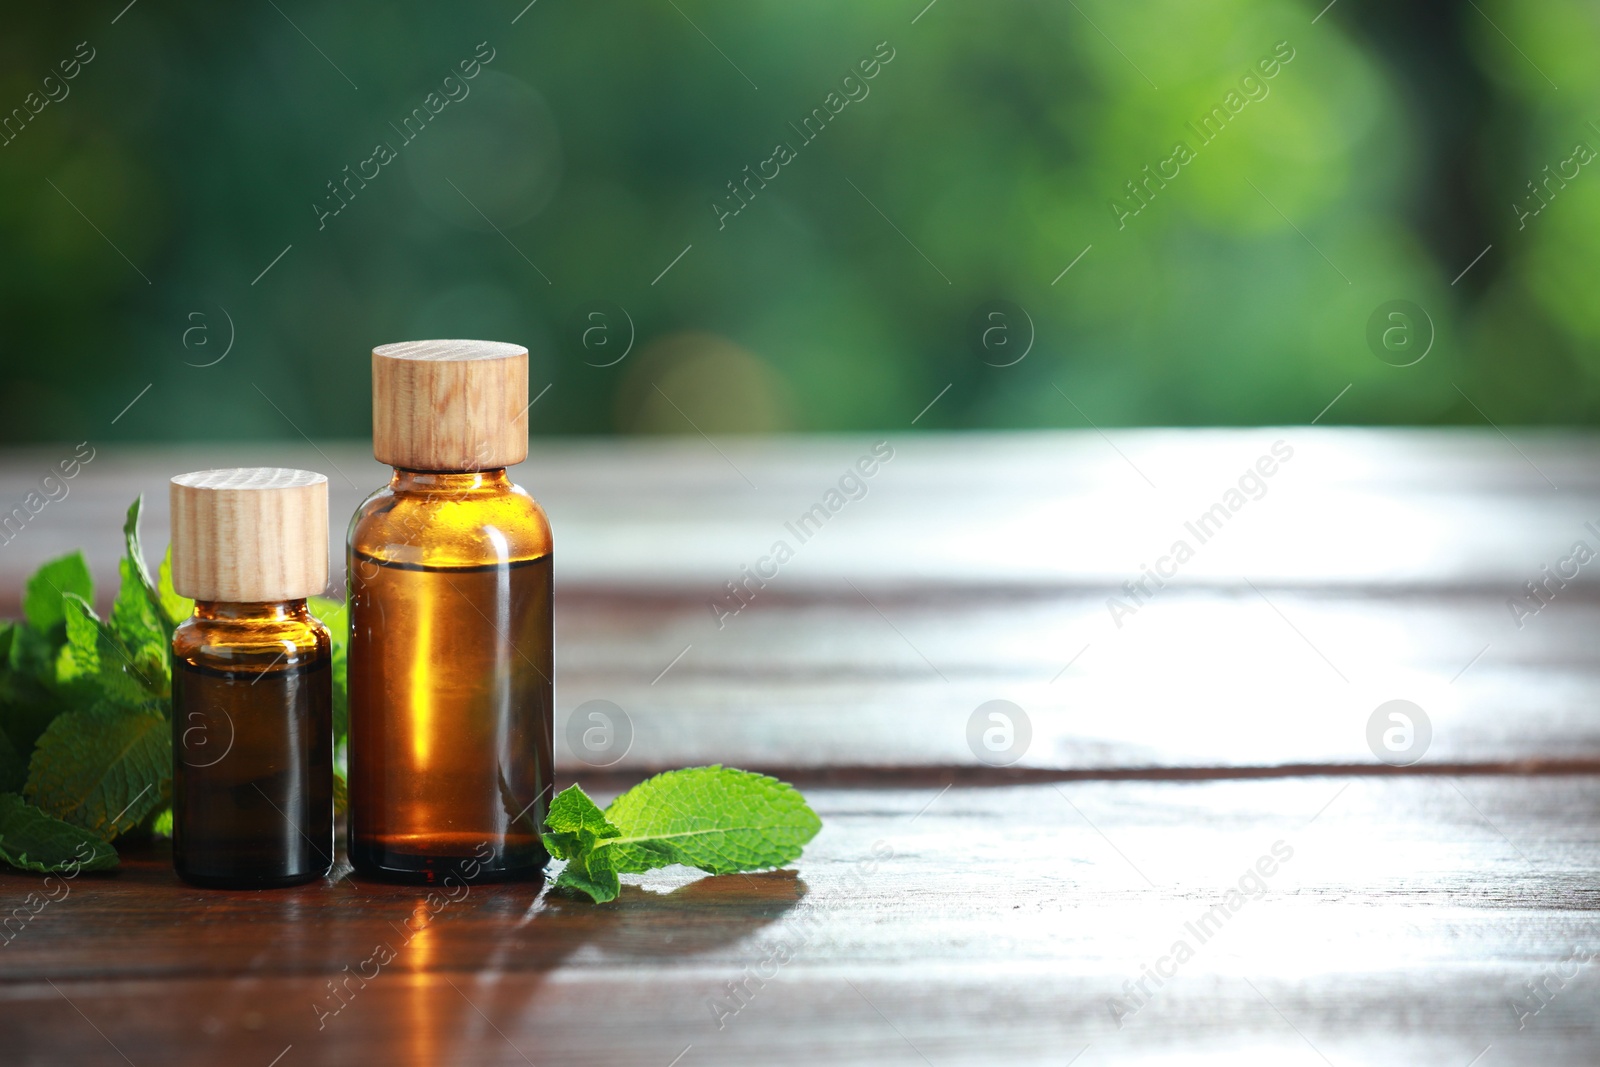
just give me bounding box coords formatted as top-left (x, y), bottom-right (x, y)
top-left (24, 702), bottom-right (173, 841)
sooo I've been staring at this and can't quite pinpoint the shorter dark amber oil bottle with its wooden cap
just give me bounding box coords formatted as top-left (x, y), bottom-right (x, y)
top-left (171, 467), bottom-right (333, 889)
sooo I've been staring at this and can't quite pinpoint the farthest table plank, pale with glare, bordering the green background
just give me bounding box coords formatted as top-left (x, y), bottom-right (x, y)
top-left (0, 427), bottom-right (1600, 595)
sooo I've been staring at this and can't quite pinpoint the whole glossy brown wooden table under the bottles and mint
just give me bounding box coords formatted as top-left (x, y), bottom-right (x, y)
top-left (0, 427), bottom-right (1600, 1067)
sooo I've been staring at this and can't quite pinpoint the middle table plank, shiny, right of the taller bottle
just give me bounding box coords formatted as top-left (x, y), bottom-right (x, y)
top-left (557, 590), bottom-right (1600, 769)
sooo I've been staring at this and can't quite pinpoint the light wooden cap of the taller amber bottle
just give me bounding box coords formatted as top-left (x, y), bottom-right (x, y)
top-left (373, 341), bottom-right (528, 470)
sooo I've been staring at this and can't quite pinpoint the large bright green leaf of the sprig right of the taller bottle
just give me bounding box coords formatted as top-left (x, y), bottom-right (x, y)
top-left (603, 765), bottom-right (822, 875)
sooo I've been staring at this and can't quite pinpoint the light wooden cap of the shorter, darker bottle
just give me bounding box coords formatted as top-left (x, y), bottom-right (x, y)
top-left (171, 467), bottom-right (328, 603)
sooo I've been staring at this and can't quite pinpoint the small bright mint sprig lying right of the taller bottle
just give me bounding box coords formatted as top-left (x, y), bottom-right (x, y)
top-left (542, 765), bottom-right (822, 904)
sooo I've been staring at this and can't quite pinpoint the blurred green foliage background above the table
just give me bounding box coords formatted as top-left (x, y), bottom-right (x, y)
top-left (0, 0), bottom-right (1600, 442)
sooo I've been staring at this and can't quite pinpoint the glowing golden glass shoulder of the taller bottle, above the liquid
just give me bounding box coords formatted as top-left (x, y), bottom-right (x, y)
top-left (347, 483), bottom-right (552, 566)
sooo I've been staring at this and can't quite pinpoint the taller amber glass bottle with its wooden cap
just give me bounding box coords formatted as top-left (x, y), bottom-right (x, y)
top-left (349, 341), bottom-right (555, 881)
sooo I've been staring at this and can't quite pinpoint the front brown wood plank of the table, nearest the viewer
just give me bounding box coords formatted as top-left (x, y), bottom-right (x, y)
top-left (0, 776), bottom-right (1600, 1067)
